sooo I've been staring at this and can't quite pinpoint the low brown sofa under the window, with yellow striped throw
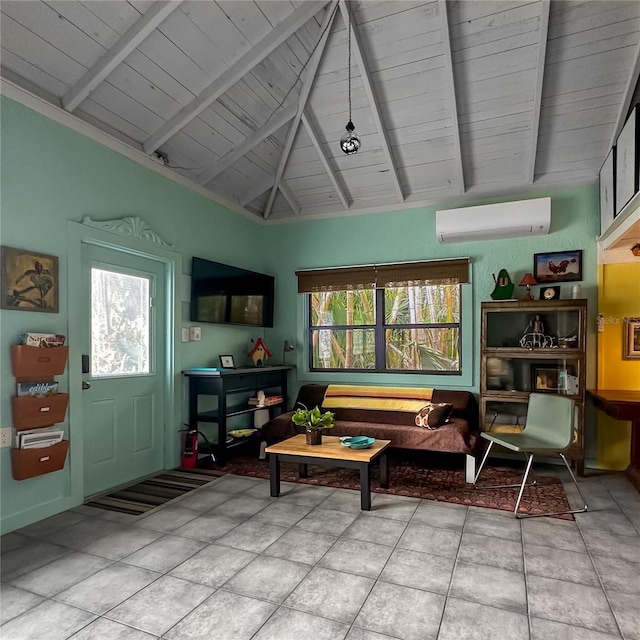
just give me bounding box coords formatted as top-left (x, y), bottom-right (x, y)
top-left (262, 384), bottom-right (480, 482)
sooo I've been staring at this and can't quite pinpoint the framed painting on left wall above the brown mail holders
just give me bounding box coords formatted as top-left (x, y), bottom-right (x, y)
top-left (0, 247), bottom-right (59, 313)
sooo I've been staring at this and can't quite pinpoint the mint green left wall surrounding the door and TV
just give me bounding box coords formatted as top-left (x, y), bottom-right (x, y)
top-left (0, 98), bottom-right (266, 530)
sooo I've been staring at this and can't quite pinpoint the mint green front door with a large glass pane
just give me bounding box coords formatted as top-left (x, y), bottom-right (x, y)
top-left (82, 244), bottom-right (166, 497)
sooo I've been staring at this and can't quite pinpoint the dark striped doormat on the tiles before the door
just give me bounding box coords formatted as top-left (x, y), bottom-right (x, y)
top-left (85, 469), bottom-right (225, 516)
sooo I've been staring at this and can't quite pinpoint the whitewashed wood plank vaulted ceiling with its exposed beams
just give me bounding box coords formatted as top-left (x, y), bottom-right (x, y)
top-left (0, 0), bottom-right (640, 220)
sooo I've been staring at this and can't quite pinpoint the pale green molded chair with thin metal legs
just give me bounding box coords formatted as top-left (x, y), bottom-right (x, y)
top-left (473, 393), bottom-right (588, 518)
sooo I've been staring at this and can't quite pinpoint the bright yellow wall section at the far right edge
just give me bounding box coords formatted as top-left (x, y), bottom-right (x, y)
top-left (597, 260), bottom-right (640, 470)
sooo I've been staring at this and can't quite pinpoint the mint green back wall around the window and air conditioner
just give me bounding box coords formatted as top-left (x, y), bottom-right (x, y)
top-left (266, 186), bottom-right (600, 392)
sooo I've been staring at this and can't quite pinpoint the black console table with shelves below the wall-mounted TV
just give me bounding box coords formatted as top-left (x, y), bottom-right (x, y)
top-left (182, 366), bottom-right (293, 465)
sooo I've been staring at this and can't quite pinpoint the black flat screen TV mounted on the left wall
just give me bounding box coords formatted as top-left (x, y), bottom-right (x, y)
top-left (191, 258), bottom-right (275, 327)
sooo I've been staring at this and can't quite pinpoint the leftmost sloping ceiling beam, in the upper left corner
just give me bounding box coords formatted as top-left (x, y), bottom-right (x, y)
top-left (62, 0), bottom-right (182, 112)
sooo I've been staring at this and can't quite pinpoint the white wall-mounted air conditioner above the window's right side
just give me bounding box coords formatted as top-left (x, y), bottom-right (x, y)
top-left (436, 198), bottom-right (551, 242)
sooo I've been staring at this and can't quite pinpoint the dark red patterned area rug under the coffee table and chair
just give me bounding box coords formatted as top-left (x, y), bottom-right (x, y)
top-left (222, 456), bottom-right (573, 519)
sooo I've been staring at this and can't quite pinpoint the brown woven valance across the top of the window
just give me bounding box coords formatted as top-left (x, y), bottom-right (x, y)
top-left (296, 258), bottom-right (470, 293)
